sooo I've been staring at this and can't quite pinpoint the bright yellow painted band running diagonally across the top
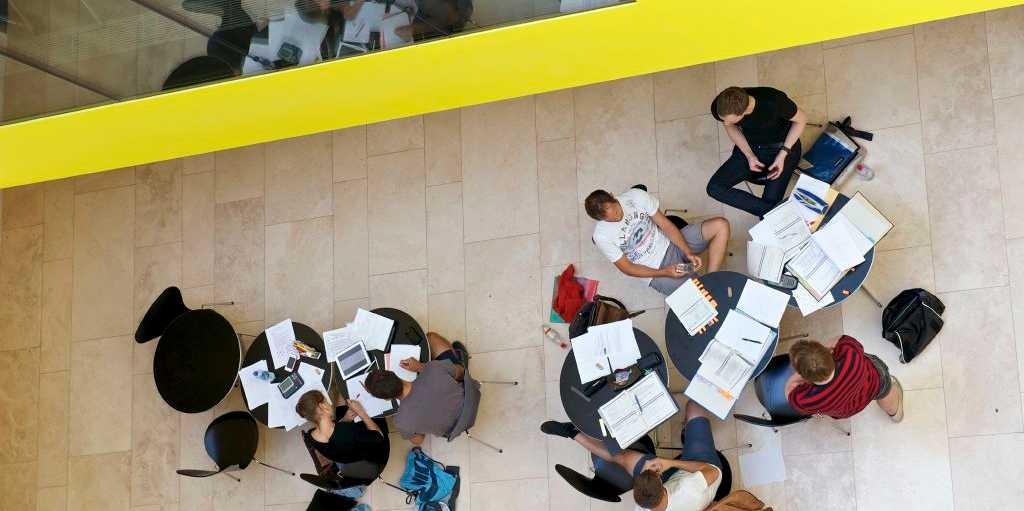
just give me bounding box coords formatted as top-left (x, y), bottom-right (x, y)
top-left (0, 0), bottom-right (1024, 187)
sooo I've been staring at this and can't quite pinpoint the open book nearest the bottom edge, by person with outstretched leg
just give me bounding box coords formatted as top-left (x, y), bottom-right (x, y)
top-left (597, 371), bottom-right (679, 449)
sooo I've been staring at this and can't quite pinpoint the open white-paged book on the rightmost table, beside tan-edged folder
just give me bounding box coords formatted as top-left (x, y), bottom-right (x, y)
top-left (786, 221), bottom-right (867, 300)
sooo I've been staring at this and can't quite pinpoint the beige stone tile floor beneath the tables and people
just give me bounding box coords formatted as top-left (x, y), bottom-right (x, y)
top-left (6, 8), bottom-right (1024, 511)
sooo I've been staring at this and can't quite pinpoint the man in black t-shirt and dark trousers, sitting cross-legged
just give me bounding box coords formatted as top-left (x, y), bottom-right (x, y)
top-left (708, 87), bottom-right (807, 217)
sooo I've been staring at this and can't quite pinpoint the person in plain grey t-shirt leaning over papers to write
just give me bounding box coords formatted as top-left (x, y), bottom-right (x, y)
top-left (365, 332), bottom-right (466, 445)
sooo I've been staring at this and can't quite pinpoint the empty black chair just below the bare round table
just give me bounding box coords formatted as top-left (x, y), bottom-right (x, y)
top-left (177, 412), bottom-right (295, 482)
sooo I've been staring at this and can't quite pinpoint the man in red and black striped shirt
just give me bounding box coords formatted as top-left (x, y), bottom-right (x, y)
top-left (785, 335), bottom-right (903, 422)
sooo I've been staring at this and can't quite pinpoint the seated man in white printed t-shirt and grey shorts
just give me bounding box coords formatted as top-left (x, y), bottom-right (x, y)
top-left (584, 187), bottom-right (729, 295)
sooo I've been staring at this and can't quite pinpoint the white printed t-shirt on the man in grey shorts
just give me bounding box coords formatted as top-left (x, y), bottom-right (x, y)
top-left (594, 188), bottom-right (670, 282)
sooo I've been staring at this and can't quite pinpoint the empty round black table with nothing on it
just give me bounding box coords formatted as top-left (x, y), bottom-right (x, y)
top-left (153, 309), bottom-right (242, 414)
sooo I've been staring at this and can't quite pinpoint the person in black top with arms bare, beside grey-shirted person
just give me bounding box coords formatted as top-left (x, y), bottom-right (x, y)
top-left (295, 390), bottom-right (389, 464)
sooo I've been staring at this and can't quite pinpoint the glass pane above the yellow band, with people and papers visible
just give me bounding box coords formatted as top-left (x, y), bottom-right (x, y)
top-left (0, 0), bottom-right (632, 123)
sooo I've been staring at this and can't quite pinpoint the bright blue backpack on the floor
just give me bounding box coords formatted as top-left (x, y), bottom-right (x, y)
top-left (398, 448), bottom-right (459, 511)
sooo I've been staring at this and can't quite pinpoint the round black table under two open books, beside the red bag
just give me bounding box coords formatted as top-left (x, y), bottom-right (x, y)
top-left (558, 328), bottom-right (669, 445)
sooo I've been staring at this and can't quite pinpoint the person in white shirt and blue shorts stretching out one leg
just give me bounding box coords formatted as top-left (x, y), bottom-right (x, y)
top-left (541, 401), bottom-right (722, 511)
